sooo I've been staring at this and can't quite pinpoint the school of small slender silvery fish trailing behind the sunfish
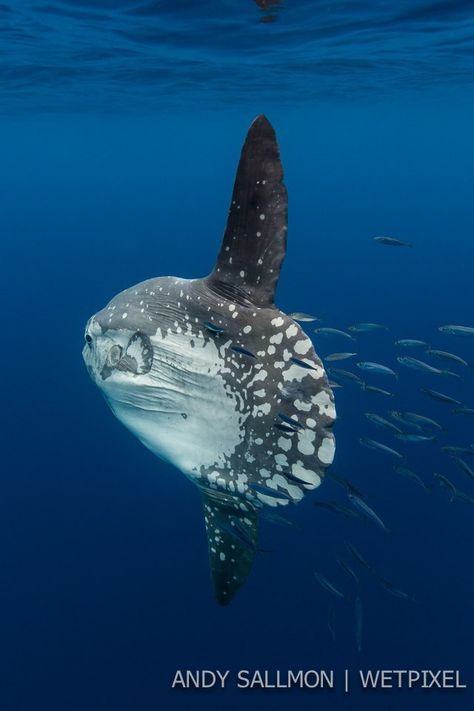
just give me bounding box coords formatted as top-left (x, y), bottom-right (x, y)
top-left (273, 242), bottom-right (474, 652)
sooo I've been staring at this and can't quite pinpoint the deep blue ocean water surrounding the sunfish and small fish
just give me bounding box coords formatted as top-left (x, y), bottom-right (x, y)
top-left (0, 0), bottom-right (474, 711)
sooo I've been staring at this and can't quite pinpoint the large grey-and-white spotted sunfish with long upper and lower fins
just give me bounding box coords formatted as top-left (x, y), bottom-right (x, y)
top-left (83, 116), bottom-right (336, 604)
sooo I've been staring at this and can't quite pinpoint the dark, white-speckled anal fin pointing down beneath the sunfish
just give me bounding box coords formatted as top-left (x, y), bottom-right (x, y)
top-left (203, 492), bottom-right (258, 605)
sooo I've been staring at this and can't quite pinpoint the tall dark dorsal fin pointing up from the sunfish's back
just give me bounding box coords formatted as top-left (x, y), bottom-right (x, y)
top-left (207, 116), bottom-right (288, 306)
